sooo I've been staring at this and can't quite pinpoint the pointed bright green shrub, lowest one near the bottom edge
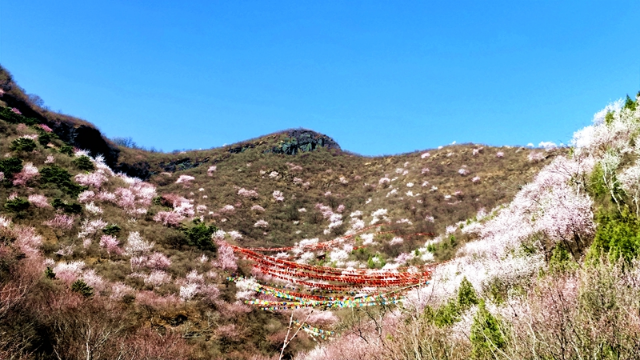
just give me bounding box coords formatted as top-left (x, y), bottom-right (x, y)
top-left (470, 300), bottom-right (507, 359)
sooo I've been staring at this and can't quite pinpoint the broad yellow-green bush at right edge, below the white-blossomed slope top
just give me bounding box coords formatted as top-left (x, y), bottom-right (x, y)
top-left (587, 206), bottom-right (640, 263)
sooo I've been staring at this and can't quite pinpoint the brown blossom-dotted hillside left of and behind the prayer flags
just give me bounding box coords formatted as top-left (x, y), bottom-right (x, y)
top-left (0, 65), bottom-right (568, 359)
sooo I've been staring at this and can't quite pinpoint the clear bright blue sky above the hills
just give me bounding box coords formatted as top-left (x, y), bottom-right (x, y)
top-left (0, 0), bottom-right (640, 155)
